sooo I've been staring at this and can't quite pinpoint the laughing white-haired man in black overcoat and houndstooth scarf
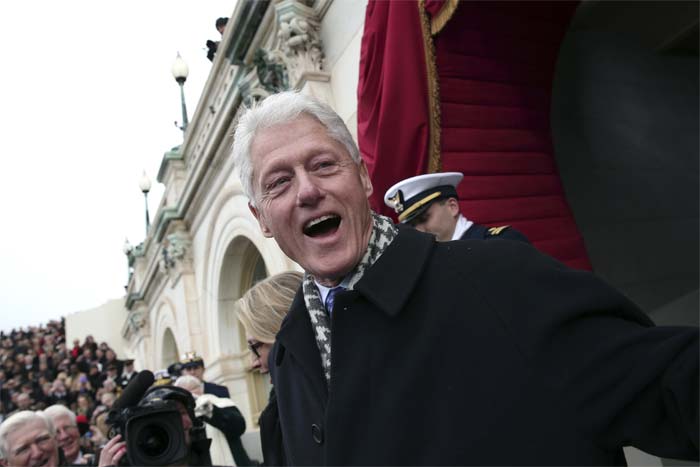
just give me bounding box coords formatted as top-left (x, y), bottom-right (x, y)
top-left (233, 92), bottom-right (698, 465)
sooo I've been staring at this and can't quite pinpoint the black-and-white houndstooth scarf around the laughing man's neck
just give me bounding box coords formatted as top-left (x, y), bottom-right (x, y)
top-left (302, 212), bottom-right (397, 383)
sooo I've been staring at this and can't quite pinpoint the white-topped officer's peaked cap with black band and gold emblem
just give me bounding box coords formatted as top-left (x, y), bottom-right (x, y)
top-left (384, 172), bottom-right (464, 223)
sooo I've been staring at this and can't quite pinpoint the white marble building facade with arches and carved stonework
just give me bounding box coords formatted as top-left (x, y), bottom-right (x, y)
top-left (110, 0), bottom-right (367, 430)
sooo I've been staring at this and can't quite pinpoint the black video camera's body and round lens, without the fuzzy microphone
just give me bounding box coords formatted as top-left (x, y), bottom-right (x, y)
top-left (108, 400), bottom-right (189, 466)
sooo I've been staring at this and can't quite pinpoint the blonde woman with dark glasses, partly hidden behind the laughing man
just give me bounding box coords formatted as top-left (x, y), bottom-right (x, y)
top-left (237, 271), bottom-right (303, 465)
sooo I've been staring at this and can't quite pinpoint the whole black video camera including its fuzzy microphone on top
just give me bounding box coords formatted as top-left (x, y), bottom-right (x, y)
top-left (107, 370), bottom-right (206, 466)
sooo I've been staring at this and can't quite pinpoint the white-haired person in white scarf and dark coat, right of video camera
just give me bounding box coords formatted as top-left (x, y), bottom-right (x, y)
top-left (175, 375), bottom-right (253, 467)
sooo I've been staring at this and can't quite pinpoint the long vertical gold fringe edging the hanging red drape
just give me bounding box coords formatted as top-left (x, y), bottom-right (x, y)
top-left (418, 0), bottom-right (442, 173)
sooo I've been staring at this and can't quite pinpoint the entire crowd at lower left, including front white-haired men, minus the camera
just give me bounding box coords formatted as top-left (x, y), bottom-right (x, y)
top-left (0, 320), bottom-right (259, 466)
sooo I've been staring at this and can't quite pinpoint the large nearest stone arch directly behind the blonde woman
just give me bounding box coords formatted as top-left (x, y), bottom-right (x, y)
top-left (202, 185), bottom-right (298, 426)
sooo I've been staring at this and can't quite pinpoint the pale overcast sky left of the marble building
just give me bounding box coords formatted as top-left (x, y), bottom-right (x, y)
top-left (0, 0), bottom-right (235, 330)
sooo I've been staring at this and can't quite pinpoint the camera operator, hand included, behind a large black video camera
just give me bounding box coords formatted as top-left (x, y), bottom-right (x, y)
top-left (99, 371), bottom-right (211, 466)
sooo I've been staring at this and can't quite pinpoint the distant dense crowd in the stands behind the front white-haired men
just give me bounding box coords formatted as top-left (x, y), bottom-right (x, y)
top-left (0, 320), bottom-right (136, 463)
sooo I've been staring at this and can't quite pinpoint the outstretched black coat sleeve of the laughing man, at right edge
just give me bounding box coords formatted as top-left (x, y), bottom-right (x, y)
top-left (478, 242), bottom-right (700, 459)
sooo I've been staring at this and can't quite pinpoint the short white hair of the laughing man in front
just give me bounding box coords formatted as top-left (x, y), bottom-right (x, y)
top-left (233, 91), bottom-right (360, 206)
